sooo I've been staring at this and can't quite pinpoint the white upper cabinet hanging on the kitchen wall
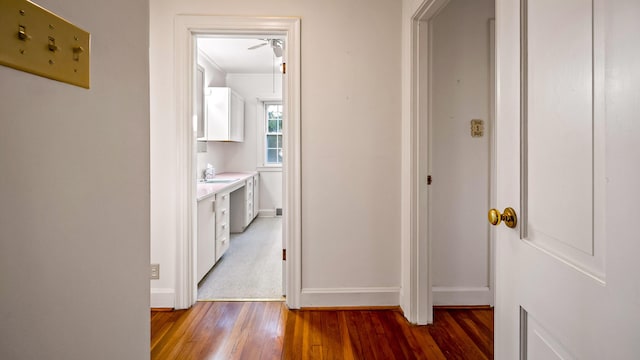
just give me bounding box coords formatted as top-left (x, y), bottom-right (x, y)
top-left (205, 87), bottom-right (244, 142)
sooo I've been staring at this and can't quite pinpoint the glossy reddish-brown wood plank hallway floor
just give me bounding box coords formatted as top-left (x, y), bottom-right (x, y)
top-left (151, 302), bottom-right (493, 360)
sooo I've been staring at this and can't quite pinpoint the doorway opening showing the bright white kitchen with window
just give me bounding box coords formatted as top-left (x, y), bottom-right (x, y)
top-left (194, 34), bottom-right (287, 301)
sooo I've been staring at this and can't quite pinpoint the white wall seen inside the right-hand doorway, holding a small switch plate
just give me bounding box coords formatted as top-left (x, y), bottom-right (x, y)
top-left (430, 0), bottom-right (494, 305)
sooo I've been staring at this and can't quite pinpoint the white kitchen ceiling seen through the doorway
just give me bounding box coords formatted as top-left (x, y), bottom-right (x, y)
top-left (197, 36), bottom-right (282, 74)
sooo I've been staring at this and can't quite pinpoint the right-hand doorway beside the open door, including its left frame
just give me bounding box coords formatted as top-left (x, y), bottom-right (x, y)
top-left (409, 0), bottom-right (495, 324)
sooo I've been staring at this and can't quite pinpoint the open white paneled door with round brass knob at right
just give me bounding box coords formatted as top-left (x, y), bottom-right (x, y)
top-left (494, 0), bottom-right (640, 360)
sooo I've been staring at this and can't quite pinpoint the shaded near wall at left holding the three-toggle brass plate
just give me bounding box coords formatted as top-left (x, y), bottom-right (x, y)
top-left (0, 0), bottom-right (150, 360)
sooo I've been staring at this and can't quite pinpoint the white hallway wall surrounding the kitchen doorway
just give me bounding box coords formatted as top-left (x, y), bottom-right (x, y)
top-left (150, 0), bottom-right (401, 306)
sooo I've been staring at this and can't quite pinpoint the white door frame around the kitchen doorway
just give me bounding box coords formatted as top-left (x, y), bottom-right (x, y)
top-left (174, 15), bottom-right (302, 309)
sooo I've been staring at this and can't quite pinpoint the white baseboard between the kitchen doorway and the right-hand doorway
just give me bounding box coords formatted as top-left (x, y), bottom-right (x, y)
top-left (300, 287), bottom-right (400, 307)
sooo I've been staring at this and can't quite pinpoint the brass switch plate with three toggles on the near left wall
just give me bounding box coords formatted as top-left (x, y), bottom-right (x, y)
top-left (0, 0), bottom-right (90, 89)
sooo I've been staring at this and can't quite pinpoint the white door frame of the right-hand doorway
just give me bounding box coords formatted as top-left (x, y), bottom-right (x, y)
top-left (402, 0), bottom-right (495, 325)
